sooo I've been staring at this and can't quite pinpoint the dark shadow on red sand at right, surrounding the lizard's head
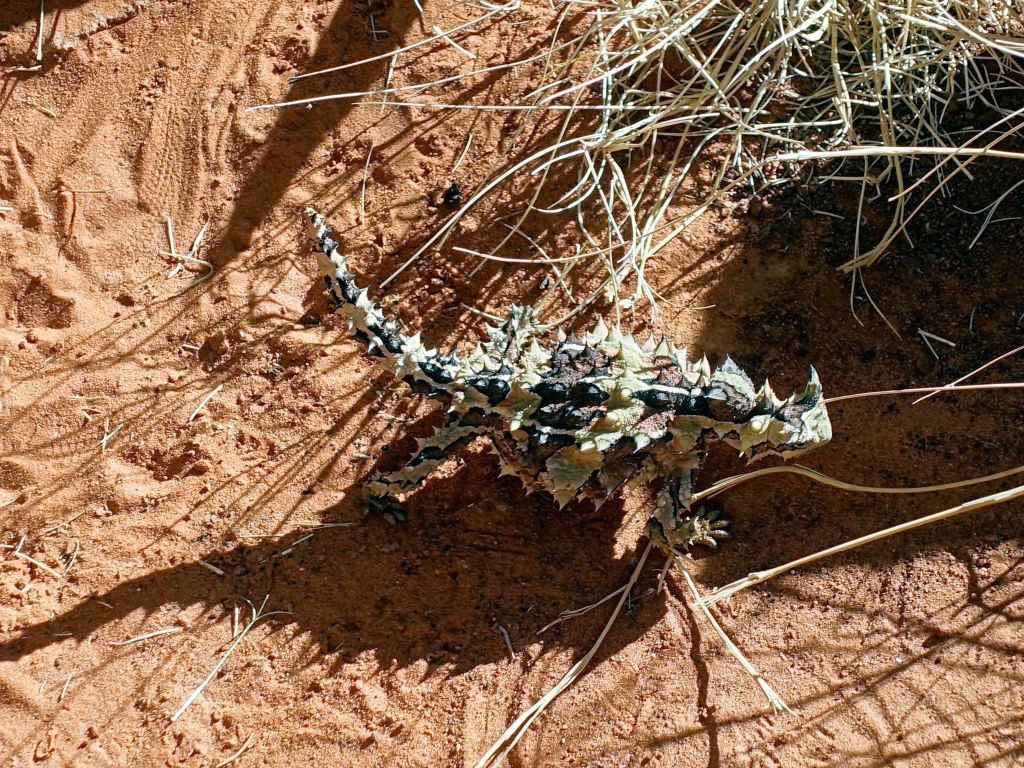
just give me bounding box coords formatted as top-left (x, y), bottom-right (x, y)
top-left (679, 166), bottom-right (1022, 582)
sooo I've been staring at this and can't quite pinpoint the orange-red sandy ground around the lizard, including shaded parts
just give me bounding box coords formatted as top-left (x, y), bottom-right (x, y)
top-left (0, 0), bottom-right (1024, 768)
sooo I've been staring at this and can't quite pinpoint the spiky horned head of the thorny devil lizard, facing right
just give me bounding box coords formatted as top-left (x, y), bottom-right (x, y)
top-left (723, 367), bottom-right (831, 462)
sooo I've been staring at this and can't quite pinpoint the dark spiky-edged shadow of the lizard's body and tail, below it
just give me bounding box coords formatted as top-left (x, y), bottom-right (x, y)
top-left (0, 461), bottom-right (660, 675)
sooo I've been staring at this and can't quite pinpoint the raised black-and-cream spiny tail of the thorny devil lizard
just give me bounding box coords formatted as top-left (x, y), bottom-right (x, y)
top-left (305, 208), bottom-right (460, 395)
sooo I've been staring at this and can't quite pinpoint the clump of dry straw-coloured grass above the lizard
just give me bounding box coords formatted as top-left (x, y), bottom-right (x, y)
top-left (270, 0), bottom-right (1024, 319)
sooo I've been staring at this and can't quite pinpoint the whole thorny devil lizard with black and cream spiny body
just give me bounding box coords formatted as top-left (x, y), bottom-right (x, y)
top-left (306, 209), bottom-right (831, 551)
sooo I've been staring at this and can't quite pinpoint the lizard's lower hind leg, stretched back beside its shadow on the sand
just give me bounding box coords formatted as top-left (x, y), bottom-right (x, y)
top-left (362, 422), bottom-right (481, 522)
